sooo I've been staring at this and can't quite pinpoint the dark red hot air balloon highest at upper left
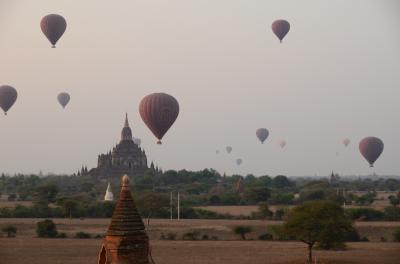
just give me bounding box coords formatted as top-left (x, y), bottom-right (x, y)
top-left (40, 14), bottom-right (67, 48)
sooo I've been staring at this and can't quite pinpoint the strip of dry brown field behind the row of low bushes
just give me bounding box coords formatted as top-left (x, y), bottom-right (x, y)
top-left (0, 218), bottom-right (400, 242)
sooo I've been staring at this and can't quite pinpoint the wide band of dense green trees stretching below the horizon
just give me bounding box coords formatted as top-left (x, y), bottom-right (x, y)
top-left (0, 169), bottom-right (400, 220)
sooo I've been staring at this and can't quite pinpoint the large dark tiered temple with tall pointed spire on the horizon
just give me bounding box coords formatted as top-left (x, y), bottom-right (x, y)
top-left (86, 115), bottom-right (149, 179)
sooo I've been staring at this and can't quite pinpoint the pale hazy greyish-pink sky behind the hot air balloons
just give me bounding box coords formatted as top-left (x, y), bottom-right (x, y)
top-left (0, 0), bottom-right (400, 176)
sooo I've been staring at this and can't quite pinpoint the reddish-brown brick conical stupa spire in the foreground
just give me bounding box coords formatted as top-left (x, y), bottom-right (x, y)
top-left (98, 175), bottom-right (151, 264)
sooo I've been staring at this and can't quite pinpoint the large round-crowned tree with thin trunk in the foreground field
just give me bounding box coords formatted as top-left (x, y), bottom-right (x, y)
top-left (284, 201), bottom-right (352, 263)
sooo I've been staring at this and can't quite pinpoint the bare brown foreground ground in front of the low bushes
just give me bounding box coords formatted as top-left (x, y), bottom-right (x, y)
top-left (0, 238), bottom-right (400, 264)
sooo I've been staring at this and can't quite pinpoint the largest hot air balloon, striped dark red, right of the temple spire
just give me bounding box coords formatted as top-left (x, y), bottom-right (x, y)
top-left (139, 93), bottom-right (179, 144)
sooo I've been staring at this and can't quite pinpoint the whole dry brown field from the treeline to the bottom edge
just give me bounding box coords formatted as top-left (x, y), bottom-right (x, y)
top-left (0, 219), bottom-right (400, 264)
